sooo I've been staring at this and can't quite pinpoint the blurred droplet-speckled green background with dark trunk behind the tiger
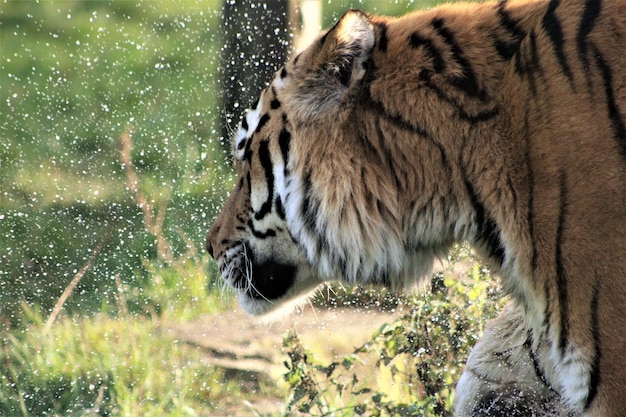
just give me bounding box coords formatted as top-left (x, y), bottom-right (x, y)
top-left (0, 0), bottom-right (424, 319)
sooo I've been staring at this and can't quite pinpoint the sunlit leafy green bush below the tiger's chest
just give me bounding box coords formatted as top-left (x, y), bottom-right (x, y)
top-left (283, 249), bottom-right (504, 416)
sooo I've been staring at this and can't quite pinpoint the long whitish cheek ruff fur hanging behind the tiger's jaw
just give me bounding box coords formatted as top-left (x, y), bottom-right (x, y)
top-left (283, 164), bottom-right (432, 289)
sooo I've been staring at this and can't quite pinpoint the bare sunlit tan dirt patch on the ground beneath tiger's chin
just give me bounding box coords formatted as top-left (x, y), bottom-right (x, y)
top-left (165, 305), bottom-right (402, 417)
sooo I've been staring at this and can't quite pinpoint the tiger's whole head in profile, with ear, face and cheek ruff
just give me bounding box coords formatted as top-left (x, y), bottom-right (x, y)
top-left (206, 11), bottom-right (444, 314)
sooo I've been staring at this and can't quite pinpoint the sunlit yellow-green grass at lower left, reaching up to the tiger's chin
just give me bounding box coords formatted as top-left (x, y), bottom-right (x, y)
top-left (0, 258), bottom-right (277, 417)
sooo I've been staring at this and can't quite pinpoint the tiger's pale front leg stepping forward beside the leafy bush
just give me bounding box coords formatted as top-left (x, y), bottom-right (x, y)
top-left (455, 305), bottom-right (577, 417)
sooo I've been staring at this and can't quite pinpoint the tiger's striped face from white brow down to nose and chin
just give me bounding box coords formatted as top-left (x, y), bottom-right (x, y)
top-left (207, 95), bottom-right (320, 315)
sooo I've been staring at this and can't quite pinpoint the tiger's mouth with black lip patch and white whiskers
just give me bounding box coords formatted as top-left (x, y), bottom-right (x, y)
top-left (220, 244), bottom-right (297, 301)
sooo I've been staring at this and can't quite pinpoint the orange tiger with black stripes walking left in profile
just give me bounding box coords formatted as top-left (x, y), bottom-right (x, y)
top-left (206, 0), bottom-right (626, 417)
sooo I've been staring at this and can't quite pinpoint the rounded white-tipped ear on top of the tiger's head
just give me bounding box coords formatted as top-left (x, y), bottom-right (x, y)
top-left (310, 10), bottom-right (376, 87)
